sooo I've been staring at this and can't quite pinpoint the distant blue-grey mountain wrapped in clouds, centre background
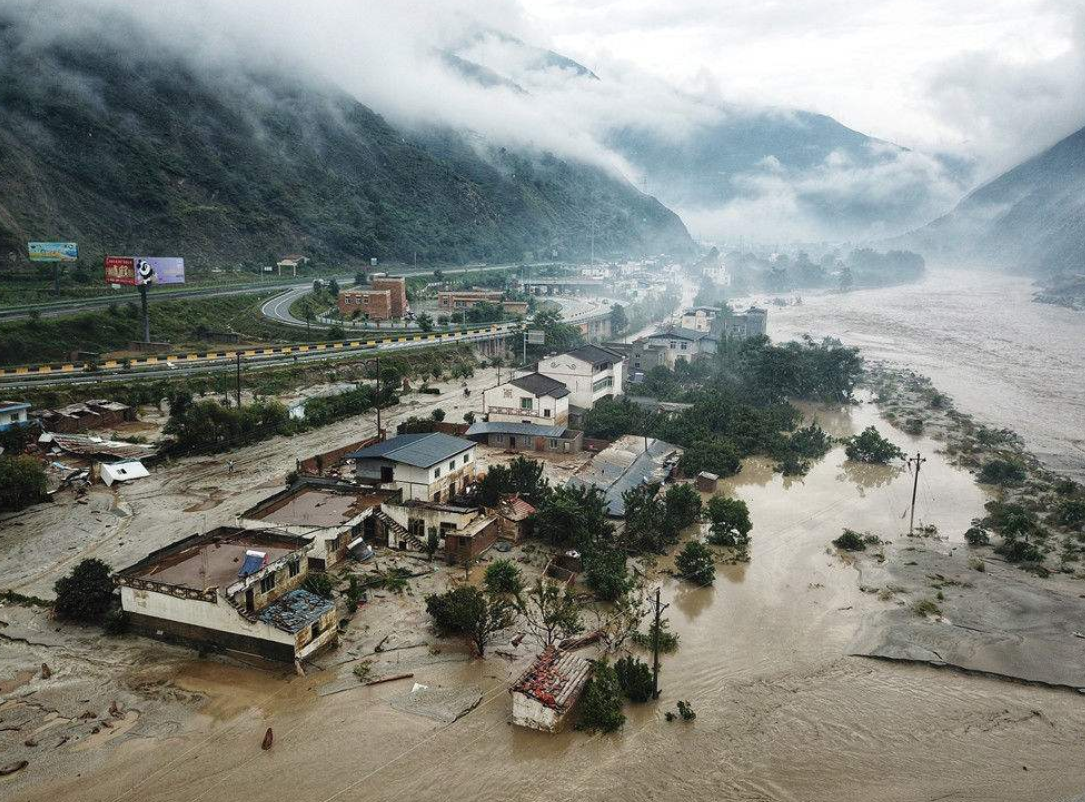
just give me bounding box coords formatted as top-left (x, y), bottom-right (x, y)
top-left (440, 30), bottom-right (970, 240)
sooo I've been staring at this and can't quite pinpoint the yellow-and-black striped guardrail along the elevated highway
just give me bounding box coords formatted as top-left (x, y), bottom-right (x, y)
top-left (0, 323), bottom-right (520, 380)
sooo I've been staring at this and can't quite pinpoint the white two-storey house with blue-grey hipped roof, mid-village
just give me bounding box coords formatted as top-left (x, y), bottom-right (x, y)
top-left (347, 432), bottom-right (476, 501)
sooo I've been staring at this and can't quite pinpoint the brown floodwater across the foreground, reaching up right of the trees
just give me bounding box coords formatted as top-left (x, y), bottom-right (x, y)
top-left (14, 403), bottom-right (1085, 802)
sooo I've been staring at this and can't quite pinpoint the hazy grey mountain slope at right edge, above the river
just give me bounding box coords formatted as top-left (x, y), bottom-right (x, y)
top-left (907, 128), bottom-right (1085, 272)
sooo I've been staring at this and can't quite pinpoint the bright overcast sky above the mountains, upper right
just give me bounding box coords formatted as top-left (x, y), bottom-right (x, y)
top-left (522, 0), bottom-right (1085, 171)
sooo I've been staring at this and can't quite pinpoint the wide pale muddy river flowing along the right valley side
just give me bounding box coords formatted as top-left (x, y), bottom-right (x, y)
top-left (768, 268), bottom-right (1085, 479)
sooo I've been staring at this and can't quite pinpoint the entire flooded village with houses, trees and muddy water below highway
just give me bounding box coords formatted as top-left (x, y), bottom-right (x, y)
top-left (0, 252), bottom-right (1085, 800)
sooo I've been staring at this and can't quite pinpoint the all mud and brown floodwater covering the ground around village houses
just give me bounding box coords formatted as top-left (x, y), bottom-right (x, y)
top-left (0, 371), bottom-right (1085, 802)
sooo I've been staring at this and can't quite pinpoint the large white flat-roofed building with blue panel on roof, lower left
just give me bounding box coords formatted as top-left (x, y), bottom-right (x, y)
top-left (114, 526), bottom-right (339, 661)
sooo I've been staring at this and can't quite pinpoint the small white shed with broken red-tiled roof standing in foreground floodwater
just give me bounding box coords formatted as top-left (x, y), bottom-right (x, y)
top-left (510, 646), bottom-right (591, 733)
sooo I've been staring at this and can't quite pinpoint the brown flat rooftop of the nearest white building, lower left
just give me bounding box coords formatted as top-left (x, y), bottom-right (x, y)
top-left (117, 526), bottom-right (308, 593)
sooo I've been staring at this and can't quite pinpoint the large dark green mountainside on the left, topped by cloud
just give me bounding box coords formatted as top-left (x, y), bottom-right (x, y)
top-left (0, 15), bottom-right (692, 267)
